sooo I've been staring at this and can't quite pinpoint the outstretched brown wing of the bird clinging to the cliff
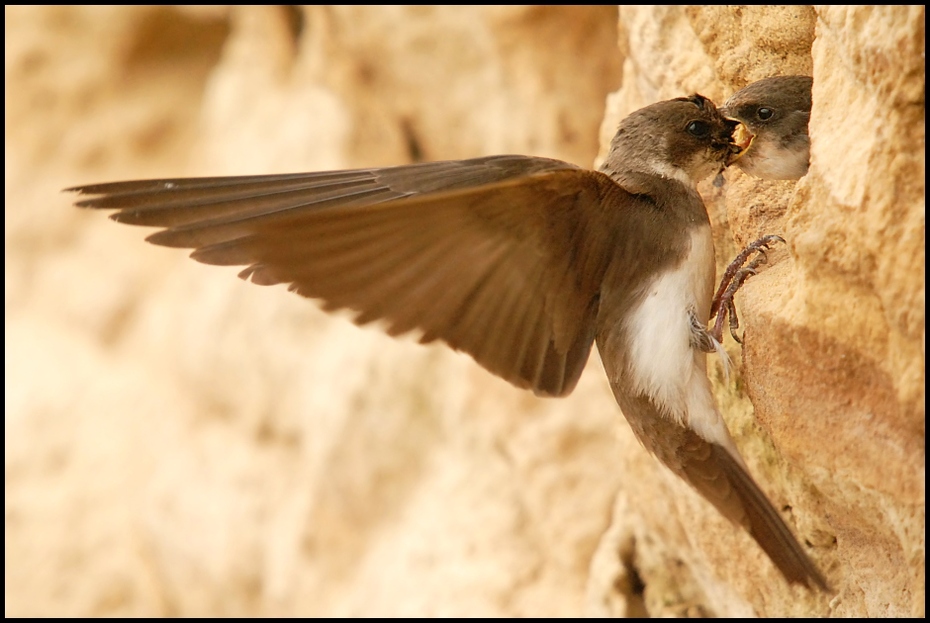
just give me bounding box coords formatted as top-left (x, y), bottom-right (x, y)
top-left (69, 156), bottom-right (631, 396)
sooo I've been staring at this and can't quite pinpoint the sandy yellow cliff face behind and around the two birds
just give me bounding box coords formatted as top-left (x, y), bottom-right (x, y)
top-left (5, 7), bottom-right (925, 616)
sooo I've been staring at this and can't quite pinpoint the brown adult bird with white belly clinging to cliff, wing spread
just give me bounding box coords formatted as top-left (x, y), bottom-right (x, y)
top-left (70, 95), bottom-right (826, 587)
